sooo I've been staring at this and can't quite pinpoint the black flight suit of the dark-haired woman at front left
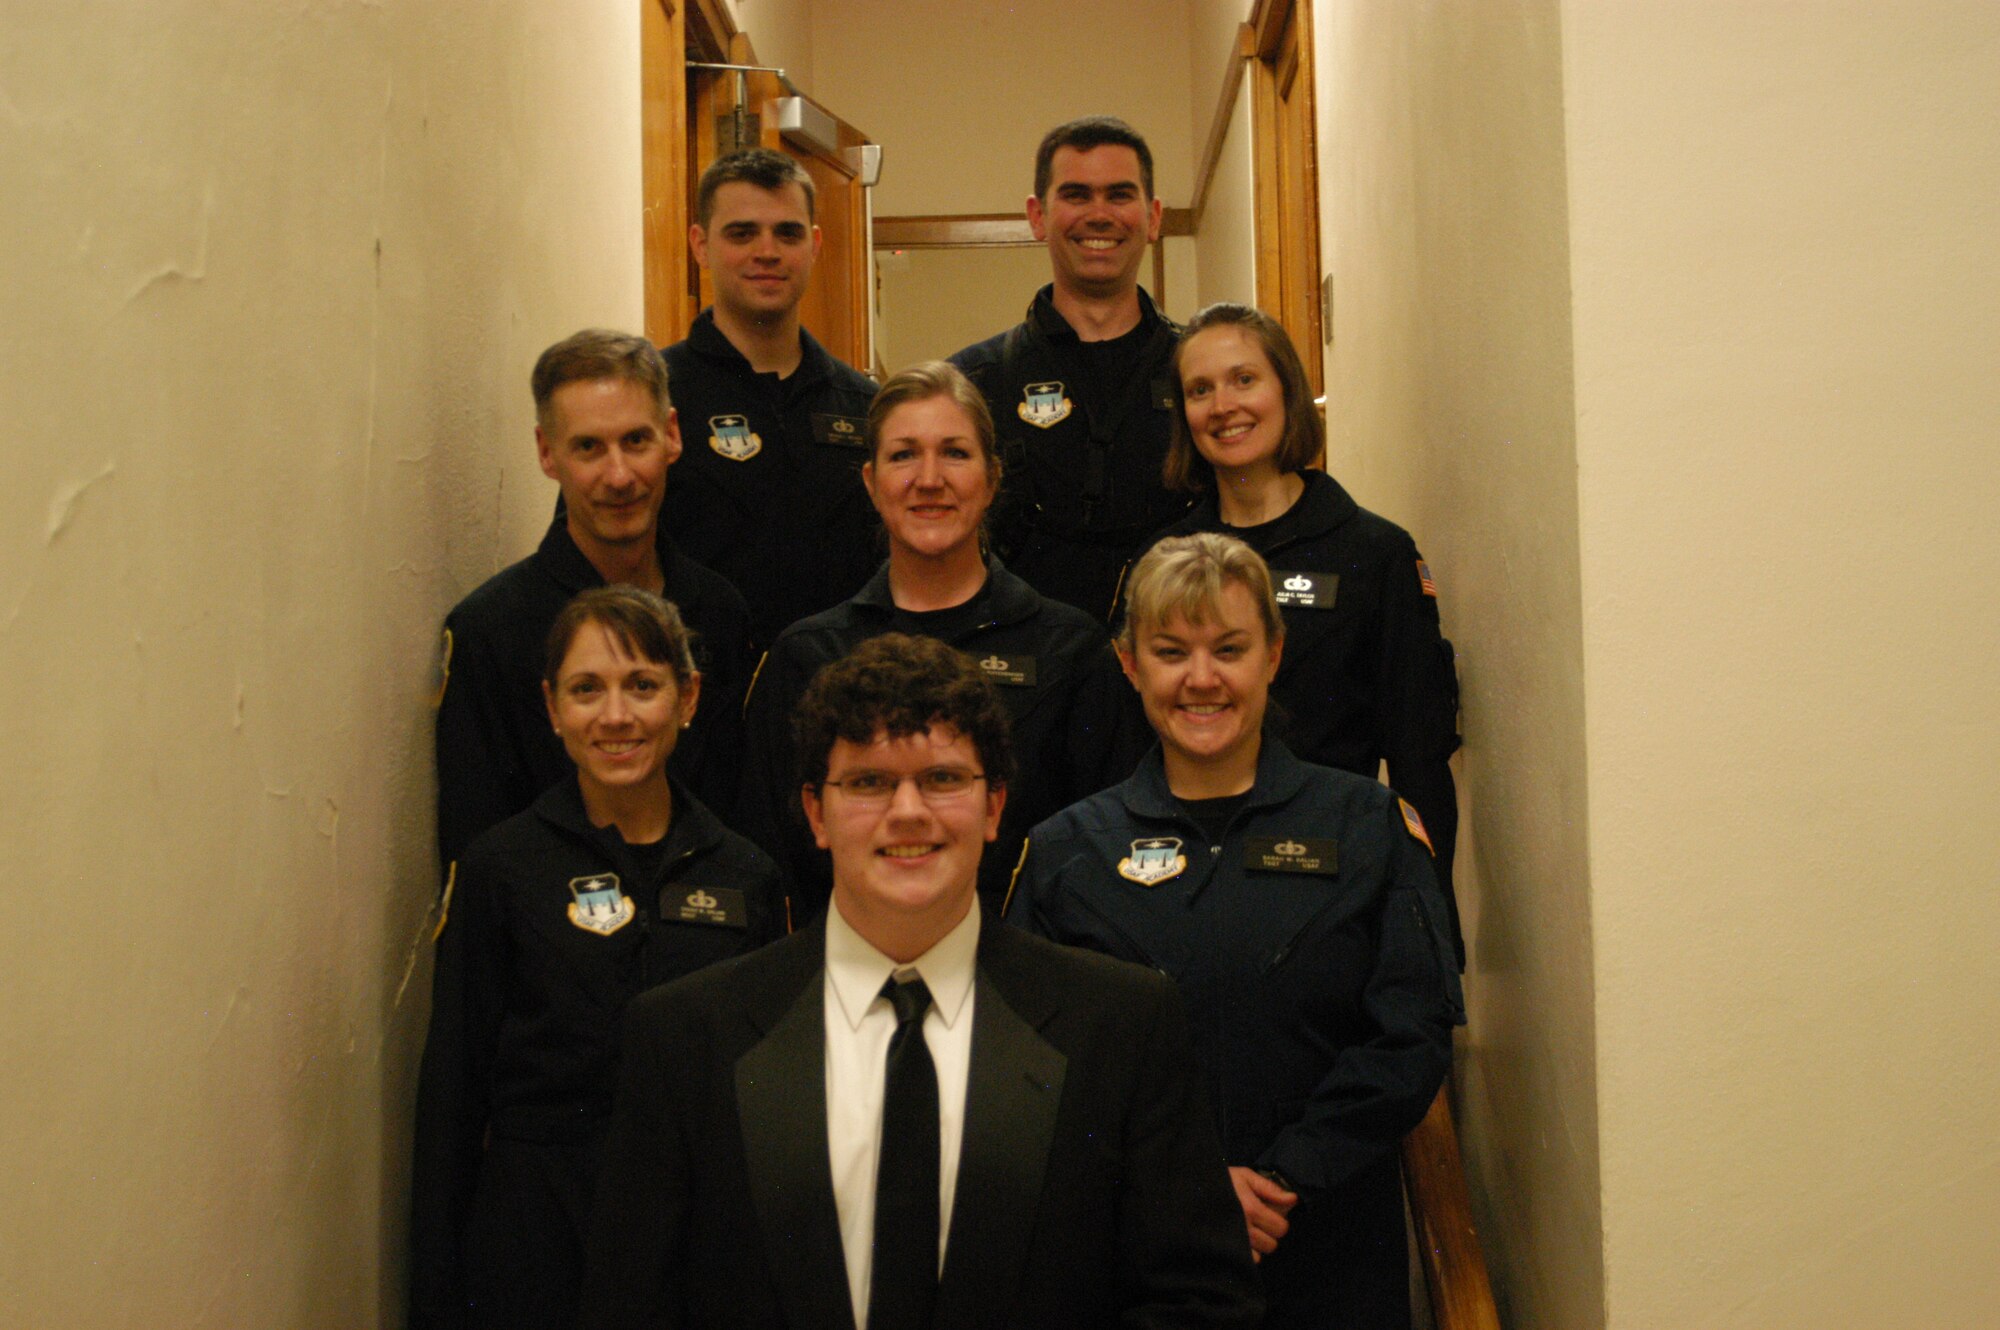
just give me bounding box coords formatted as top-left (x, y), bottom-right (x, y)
top-left (410, 778), bottom-right (784, 1330)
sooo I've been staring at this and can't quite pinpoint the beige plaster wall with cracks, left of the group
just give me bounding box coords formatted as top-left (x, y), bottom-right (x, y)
top-left (0, 0), bottom-right (640, 1330)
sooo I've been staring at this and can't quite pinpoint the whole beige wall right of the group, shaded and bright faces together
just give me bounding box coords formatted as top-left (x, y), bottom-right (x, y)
top-left (1316, 0), bottom-right (2000, 1330)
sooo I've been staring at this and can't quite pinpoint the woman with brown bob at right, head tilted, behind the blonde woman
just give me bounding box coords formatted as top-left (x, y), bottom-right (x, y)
top-left (1164, 304), bottom-right (1466, 970)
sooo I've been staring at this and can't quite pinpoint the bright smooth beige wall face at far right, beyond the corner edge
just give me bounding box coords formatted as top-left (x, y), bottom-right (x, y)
top-left (1562, 0), bottom-right (2000, 1330)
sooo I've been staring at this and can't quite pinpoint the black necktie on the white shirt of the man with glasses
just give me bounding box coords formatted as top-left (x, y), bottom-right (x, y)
top-left (868, 976), bottom-right (938, 1330)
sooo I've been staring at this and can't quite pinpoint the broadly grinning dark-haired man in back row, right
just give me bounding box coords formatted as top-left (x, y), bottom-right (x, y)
top-left (952, 116), bottom-right (1188, 622)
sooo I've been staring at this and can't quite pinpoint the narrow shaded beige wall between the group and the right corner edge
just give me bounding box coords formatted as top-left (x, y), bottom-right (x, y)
top-left (1314, 0), bottom-right (1600, 1330)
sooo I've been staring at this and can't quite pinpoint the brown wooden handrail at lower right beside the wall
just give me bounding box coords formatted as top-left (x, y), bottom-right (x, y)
top-left (1402, 1088), bottom-right (1500, 1330)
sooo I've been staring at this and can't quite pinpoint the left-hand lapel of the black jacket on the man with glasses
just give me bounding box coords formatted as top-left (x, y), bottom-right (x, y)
top-left (736, 924), bottom-right (854, 1328)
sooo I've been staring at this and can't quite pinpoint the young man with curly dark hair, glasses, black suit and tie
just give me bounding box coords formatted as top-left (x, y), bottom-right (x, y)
top-left (580, 634), bottom-right (1262, 1330)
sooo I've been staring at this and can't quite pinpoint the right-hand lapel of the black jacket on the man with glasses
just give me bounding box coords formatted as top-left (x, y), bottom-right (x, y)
top-left (934, 920), bottom-right (1068, 1326)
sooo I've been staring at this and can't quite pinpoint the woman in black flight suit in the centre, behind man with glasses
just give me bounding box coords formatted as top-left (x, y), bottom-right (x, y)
top-left (738, 360), bottom-right (1146, 926)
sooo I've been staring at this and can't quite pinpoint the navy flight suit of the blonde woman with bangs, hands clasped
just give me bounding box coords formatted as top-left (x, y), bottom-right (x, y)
top-left (1006, 736), bottom-right (1462, 1330)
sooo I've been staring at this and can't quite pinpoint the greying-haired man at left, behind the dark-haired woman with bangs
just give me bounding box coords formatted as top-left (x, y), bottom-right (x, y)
top-left (436, 328), bottom-right (752, 868)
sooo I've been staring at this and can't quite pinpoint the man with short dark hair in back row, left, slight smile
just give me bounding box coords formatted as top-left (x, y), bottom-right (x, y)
top-left (662, 148), bottom-right (882, 648)
